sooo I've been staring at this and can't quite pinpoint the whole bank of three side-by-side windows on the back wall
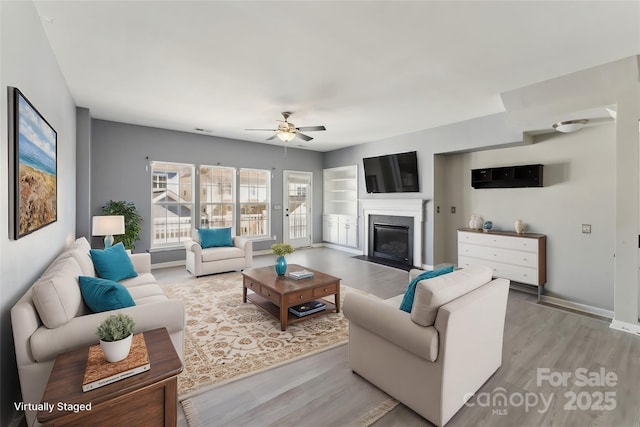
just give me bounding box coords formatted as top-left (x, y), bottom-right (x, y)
top-left (151, 161), bottom-right (271, 249)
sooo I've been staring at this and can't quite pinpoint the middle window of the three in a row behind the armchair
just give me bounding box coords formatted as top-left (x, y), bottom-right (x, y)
top-left (200, 166), bottom-right (236, 228)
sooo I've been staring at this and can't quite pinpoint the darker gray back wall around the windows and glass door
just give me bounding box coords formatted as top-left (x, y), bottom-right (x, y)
top-left (89, 120), bottom-right (323, 263)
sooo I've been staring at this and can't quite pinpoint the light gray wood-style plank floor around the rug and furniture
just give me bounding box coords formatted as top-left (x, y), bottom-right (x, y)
top-left (153, 248), bottom-right (640, 427)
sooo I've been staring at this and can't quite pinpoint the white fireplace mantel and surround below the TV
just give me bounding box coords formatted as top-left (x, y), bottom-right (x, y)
top-left (359, 199), bottom-right (425, 268)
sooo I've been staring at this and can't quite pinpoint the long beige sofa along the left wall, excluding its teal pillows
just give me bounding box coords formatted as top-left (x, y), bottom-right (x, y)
top-left (11, 238), bottom-right (184, 426)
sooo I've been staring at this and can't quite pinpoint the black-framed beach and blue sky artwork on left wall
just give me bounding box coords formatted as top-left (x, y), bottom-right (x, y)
top-left (8, 87), bottom-right (58, 240)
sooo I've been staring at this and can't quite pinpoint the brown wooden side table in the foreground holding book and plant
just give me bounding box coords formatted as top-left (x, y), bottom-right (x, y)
top-left (37, 328), bottom-right (182, 427)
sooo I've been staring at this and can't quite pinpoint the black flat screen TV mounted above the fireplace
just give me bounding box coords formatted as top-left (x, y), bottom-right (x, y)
top-left (362, 151), bottom-right (420, 193)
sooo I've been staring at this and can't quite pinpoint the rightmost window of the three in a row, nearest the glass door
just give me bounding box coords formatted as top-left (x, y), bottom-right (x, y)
top-left (239, 169), bottom-right (271, 237)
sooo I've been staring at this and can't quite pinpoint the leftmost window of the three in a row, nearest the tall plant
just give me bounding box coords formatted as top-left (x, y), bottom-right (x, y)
top-left (151, 162), bottom-right (194, 247)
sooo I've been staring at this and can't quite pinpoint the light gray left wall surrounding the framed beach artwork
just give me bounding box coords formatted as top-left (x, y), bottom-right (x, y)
top-left (0, 1), bottom-right (76, 425)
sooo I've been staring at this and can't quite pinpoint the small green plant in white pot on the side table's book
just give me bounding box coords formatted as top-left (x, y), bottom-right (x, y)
top-left (96, 313), bottom-right (136, 362)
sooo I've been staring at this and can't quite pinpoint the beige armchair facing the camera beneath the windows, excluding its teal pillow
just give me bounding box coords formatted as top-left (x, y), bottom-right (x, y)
top-left (184, 229), bottom-right (253, 277)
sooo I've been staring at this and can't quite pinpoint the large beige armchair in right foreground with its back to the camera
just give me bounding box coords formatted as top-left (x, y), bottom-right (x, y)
top-left (344, 266), bottom-right (509, 426)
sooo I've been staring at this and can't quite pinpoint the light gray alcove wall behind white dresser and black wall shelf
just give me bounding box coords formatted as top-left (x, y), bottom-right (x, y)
top-left (437, 121), bottom-right (616, 310)
